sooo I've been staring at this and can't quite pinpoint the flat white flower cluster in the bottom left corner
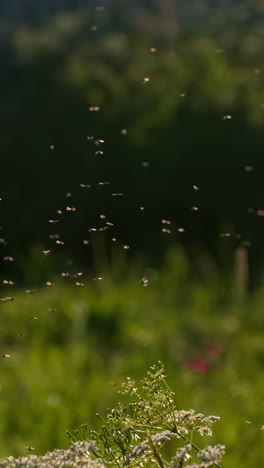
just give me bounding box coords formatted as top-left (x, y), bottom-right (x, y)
top-left (0, 441), bottom-right (105, 468)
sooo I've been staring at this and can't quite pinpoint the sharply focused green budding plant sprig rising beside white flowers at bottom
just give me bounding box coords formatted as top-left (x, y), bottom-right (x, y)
top-left (67, 362), bottom-right (224, 468)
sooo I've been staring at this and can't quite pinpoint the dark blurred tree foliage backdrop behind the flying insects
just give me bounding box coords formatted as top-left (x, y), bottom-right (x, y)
top-left (0, 0), bottom-right (264, 271)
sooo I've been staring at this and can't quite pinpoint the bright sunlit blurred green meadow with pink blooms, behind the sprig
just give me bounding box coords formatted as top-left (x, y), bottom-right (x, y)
top-left (0, 250), bottom-right (264, 468)
